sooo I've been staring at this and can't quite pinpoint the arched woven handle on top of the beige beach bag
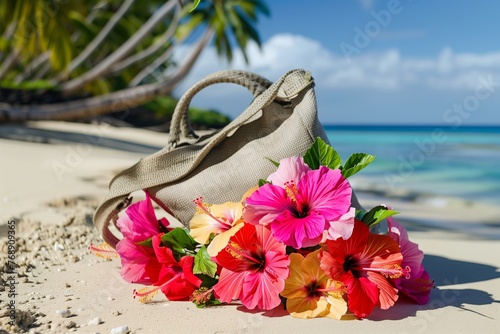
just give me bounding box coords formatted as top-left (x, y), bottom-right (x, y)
top-left (167, 70), bottom-right (272, 149)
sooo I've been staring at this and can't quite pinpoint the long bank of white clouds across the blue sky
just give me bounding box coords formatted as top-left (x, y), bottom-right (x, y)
top-left (177, 34), bottom-right (500, 90)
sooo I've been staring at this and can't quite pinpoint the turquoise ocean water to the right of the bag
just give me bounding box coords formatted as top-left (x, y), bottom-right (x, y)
top-left (325, 126), bottom-right (500, 205)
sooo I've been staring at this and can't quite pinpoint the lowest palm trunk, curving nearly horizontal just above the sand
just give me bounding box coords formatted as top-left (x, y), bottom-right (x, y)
top-left (0, 29), bottom-right (214, 123)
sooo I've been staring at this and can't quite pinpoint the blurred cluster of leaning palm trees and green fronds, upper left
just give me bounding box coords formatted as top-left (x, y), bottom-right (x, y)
top-left (0, 0), bottom-right (269, 123)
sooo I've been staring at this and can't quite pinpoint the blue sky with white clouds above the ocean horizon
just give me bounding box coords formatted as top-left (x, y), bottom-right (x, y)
top-left (173, 0), bottom-right (500, 126)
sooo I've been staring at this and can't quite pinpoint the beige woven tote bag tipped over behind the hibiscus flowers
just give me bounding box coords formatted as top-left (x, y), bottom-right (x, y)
top-left (94, 70), bottom-right (328, 247)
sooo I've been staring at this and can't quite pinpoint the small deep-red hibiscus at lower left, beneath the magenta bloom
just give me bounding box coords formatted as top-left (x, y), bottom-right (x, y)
top-left (134, 234), bottom-right (202, 300)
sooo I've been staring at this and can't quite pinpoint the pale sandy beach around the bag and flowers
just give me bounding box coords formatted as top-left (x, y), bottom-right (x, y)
top-left (0, 122), bottom-right (500, 333)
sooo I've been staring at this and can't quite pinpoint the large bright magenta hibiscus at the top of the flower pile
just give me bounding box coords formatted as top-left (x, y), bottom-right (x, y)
top-left (243, 157), bottom-right (352, 249)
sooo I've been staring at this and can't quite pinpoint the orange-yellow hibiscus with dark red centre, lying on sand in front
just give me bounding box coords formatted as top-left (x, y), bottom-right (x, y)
top-left (281, 250), bottom-right (347, 319)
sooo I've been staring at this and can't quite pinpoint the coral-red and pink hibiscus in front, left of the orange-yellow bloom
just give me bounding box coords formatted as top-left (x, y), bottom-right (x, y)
top-left (214, 224), bottom-right (290, 310)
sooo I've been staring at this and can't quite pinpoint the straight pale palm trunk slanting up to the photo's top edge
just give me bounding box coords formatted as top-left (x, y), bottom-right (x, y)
top-left (61, 0), bottom-right (177, 95)
